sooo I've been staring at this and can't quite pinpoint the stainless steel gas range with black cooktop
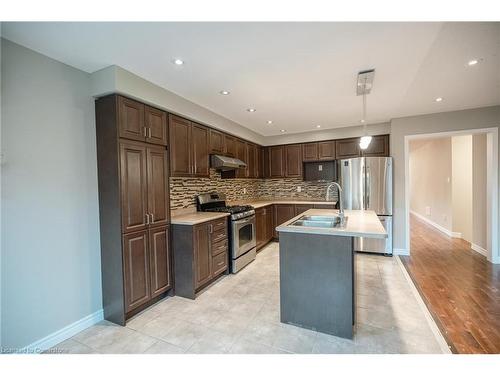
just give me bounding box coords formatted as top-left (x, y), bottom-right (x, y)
top-left (197, 192), bottom-right (257, 273)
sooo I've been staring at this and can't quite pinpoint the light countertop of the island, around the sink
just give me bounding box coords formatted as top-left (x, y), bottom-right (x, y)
top-left (276, 209), bottom-right (387, 238)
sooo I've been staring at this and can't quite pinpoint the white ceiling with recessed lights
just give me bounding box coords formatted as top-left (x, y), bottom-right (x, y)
top-left (2, 23), bottom-right (500, 136)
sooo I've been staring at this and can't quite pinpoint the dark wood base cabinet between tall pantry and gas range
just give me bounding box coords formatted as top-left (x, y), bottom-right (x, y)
top-left (172, 218), bottom-right (229, 299)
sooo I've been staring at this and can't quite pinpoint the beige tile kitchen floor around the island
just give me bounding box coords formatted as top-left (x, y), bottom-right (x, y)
top-left (49, 243), bottom-right (442, 354)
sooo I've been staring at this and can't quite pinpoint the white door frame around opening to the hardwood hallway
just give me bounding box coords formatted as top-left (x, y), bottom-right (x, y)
top-left (404, 128), bottom-right (500, 264)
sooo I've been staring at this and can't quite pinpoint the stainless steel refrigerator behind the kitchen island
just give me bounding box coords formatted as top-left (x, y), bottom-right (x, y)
top-left (338, 157), bottom-right (392, 255)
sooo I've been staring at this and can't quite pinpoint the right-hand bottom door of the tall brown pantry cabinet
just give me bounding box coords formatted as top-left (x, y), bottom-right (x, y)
top-left (149, 226), bottom-right (172, 298)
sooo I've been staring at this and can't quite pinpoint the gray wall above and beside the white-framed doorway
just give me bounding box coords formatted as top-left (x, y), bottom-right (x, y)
top-left (391, 106), bottom-right (500, 258)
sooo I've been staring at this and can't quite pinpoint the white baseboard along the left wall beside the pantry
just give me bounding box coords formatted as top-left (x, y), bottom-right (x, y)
top-left (19, 309), bottom-right (104, 354)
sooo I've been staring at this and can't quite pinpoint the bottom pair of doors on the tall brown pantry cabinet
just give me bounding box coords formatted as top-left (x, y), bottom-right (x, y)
top-left (123, 226), bottom-right (172, 313)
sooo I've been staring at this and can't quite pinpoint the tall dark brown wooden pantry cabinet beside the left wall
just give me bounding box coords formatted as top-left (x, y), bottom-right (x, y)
top-left (96, 95), bottom-right (173, 325)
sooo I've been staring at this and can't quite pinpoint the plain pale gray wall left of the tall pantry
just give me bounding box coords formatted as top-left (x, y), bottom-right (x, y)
top-left (1, 40), bottom-right (102, 348)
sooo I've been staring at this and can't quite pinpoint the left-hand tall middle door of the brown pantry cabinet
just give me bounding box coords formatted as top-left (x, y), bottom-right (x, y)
top-left (120, 141), bottom-right (148, 232)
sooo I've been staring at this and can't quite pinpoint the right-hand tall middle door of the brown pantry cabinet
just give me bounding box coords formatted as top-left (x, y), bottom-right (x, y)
top-left (147, 146), bottom-right (170, 226)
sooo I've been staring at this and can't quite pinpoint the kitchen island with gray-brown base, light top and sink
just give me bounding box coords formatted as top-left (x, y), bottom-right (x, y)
top-left (276, 209), bottom-right (387, 338)
